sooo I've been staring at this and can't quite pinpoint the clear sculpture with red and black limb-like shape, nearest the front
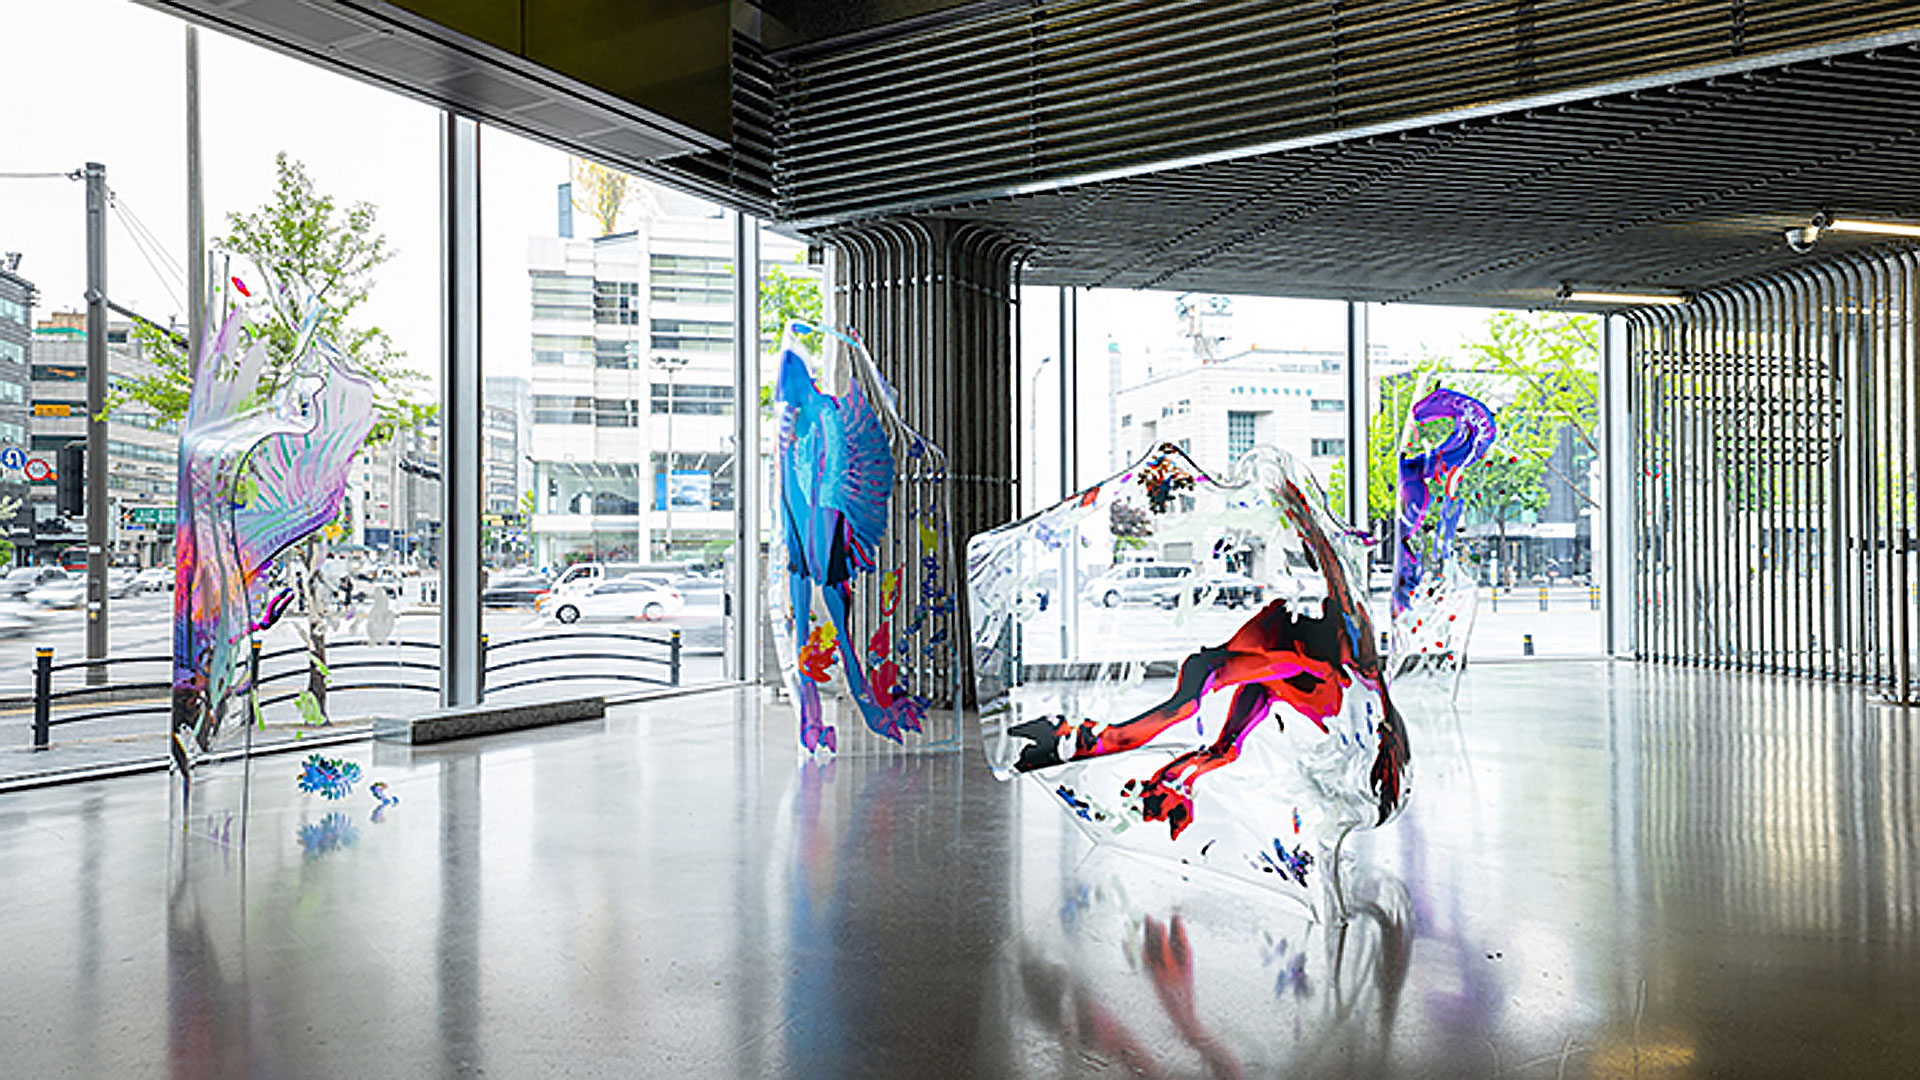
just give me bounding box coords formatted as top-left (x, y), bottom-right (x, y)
top-left (968, 444), bottom-right (1409, 907)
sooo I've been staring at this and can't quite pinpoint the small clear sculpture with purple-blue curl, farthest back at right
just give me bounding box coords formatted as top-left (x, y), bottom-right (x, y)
top-left (1392, 388), bottom-right (1500, 694)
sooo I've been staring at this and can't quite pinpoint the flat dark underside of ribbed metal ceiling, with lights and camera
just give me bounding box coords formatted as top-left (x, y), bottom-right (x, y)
top-left (967, 46), bottom-right (1920, 306)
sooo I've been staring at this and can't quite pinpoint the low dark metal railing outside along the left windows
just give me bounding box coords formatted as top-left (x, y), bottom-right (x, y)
top-left (33, 628), bottom-right (682, 749)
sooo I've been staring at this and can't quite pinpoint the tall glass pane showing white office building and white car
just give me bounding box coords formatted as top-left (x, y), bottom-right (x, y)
top-left (480, 127), bottom-right (741, 687)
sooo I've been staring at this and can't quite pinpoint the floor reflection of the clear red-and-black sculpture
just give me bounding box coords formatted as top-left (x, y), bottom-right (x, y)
top-left (1018, 859), bottom-right (1413, 1078)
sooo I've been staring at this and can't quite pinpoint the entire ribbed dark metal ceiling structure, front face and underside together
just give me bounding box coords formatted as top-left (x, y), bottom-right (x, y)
top-left (770, 0), bottom-right (1920, 306)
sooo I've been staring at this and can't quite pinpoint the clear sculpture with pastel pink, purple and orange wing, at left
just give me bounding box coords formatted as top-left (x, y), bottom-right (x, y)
top-left (173, 297), bottom-right (374, 778)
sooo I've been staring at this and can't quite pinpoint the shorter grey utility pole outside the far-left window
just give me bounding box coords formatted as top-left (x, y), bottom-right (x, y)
top-left (86, 161), bottom-right (108, 684)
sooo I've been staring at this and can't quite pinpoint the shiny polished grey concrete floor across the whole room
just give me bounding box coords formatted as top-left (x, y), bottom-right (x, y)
top-left (0, 661), bottom-right (1920, 1078)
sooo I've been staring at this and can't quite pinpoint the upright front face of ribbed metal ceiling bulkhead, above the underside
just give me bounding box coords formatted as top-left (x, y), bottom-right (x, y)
top-left (780, 0), bottom-right (1920, 223)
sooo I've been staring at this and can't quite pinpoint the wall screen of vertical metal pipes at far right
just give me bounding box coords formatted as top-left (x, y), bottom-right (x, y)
top-left (1628, 248), bottom-right (1920, 701)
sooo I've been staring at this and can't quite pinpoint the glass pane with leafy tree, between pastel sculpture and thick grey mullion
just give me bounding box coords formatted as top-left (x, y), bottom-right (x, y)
top-left (202, 23), bottom-right (444, 730)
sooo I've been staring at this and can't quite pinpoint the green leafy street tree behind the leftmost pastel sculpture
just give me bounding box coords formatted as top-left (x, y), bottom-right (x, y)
top-left (108, 152), bottom-right (434, 715)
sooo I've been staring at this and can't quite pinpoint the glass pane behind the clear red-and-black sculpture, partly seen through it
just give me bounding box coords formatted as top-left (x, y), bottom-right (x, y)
top-left (1018, 286), bottom-right (1348, 665)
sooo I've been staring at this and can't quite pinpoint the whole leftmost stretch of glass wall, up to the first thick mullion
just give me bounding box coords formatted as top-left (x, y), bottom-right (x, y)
top-left (0, 0), bottom-right (440, 774)
